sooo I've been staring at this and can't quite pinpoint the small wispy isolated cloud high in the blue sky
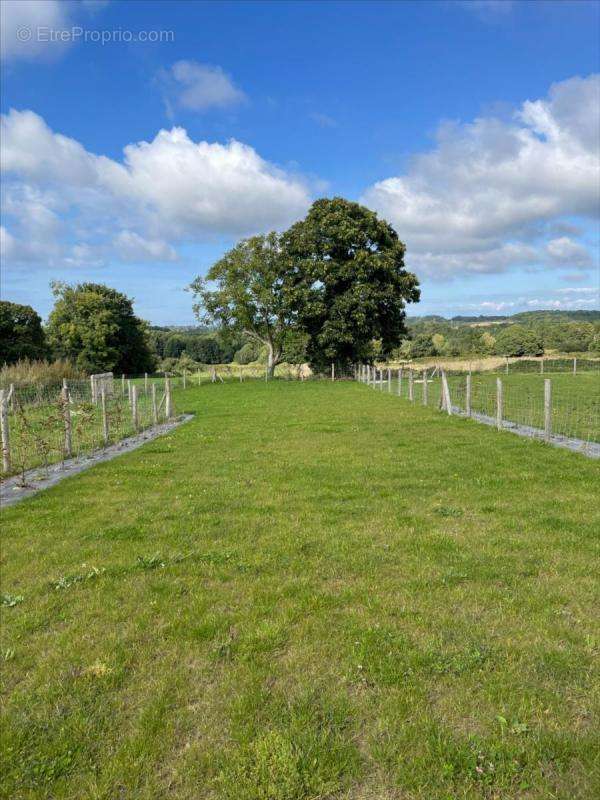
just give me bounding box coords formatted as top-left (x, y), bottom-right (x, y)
top-left (158, 61), bottom-right (247, 114)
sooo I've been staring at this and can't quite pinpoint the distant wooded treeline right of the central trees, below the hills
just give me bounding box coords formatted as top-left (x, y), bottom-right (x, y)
top-left (396, 312), bottom-right (600, 358)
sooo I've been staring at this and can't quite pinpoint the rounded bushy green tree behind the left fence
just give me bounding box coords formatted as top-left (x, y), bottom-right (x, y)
top-left (48, 283), bottom-right (154, 374)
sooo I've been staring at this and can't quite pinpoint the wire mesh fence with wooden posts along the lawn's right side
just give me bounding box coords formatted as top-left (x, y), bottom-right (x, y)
top-left (358, 365), bottom-right (600, 452)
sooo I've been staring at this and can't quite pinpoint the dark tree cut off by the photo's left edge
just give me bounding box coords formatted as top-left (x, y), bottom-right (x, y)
top-left (0, 300), bottom-right (48, 365)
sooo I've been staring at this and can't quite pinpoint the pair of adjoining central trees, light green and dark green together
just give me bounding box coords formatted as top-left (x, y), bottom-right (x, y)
top-left (191, 198), bottom-right (419, 372)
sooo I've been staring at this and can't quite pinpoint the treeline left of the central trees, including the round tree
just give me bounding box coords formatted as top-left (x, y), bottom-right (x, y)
top-left (0, 290), bottom-right (266, 380)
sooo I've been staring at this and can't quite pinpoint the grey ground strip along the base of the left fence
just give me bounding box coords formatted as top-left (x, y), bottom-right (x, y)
top-left (0, 414), bottom-right (193, 508)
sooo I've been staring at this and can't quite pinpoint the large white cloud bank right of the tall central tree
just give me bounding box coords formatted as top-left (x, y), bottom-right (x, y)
top-left (362, 75), bottom-right (600, 275)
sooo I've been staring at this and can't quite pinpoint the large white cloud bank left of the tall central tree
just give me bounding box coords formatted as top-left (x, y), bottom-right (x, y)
top-left (1, 110), bottom-right (310, 264)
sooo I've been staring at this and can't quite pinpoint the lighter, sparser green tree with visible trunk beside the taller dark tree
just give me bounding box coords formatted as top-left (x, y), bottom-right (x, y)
top-left (190, 232), bottom-right (311, 375)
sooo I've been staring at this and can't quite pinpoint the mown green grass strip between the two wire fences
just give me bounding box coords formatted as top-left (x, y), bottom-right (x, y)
top-left (0, 382), bottom-right (600, 800)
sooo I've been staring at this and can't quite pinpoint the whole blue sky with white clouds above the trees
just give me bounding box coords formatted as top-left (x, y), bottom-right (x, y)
top-left (2, 0), bottom-right (600, 324)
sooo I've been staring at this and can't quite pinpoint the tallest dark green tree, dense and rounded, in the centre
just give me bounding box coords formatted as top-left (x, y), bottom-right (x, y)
top-left (281, 197), bottom-right (420, 369)
